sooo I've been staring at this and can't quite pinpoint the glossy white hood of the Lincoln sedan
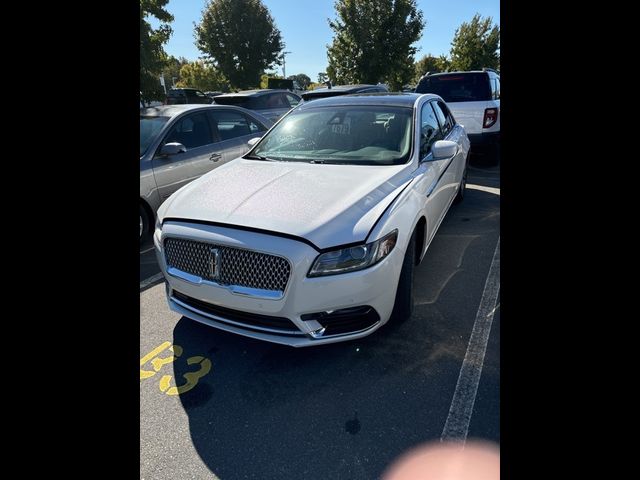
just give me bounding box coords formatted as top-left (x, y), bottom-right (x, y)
top-left (158, 158), bottom-right (411, 249)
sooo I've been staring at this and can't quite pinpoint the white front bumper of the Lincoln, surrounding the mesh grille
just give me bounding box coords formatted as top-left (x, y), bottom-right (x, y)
top-left (154, 222), bottom-right (404, 347)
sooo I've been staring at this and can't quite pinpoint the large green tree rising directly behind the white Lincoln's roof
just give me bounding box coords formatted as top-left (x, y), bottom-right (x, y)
top-left (327, 0), bottom-right (425, 90)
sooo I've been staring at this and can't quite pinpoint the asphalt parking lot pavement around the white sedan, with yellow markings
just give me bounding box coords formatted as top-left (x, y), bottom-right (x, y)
top-left (140, 163), bottom-right (500, 480)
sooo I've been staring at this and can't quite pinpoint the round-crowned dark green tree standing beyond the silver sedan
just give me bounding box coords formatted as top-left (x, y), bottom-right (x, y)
top-left (195, 0), bottom-right (284, 88)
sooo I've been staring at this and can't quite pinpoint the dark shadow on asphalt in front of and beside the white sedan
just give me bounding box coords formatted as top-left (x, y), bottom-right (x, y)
top-left (168, 178), bottom-right (499, 480)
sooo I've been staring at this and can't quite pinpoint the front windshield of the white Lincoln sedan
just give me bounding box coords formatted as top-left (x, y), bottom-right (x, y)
top-left (247, 105), bottom-right (413, 165)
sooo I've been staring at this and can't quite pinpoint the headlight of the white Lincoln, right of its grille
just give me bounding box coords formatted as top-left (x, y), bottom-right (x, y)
top-left (307, 230), bottom-right (398, 277)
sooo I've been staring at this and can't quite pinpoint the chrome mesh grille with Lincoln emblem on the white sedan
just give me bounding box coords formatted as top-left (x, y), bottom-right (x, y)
top-left (164, 238), bottom-right (291, 292)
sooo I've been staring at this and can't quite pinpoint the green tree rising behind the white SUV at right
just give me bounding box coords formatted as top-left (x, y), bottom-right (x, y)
top-left (451, 13), bottom-right (500, 70)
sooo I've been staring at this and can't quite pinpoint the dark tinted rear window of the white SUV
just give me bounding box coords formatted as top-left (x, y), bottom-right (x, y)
top-left (416, 72), bottom-right (491, 102)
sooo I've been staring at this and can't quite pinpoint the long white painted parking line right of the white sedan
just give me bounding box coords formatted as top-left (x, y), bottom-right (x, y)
top-left (440, 237), bottom-right (500, 443)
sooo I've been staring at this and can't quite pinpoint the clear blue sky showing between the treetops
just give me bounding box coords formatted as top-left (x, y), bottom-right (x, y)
top-left (150, 0), bottom-right (500, 81)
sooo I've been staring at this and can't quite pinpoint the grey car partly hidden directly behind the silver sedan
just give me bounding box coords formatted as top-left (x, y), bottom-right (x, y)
top-left (213, 89), bottom-right (301, 122)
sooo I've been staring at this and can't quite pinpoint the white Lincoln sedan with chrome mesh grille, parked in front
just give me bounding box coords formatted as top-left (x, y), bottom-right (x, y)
top-left (153, 94), bottom-right (469, 347)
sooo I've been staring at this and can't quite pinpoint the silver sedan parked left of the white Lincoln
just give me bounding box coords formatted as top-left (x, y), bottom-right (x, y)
top-left (140, 105), bottom-right (273, 243)
